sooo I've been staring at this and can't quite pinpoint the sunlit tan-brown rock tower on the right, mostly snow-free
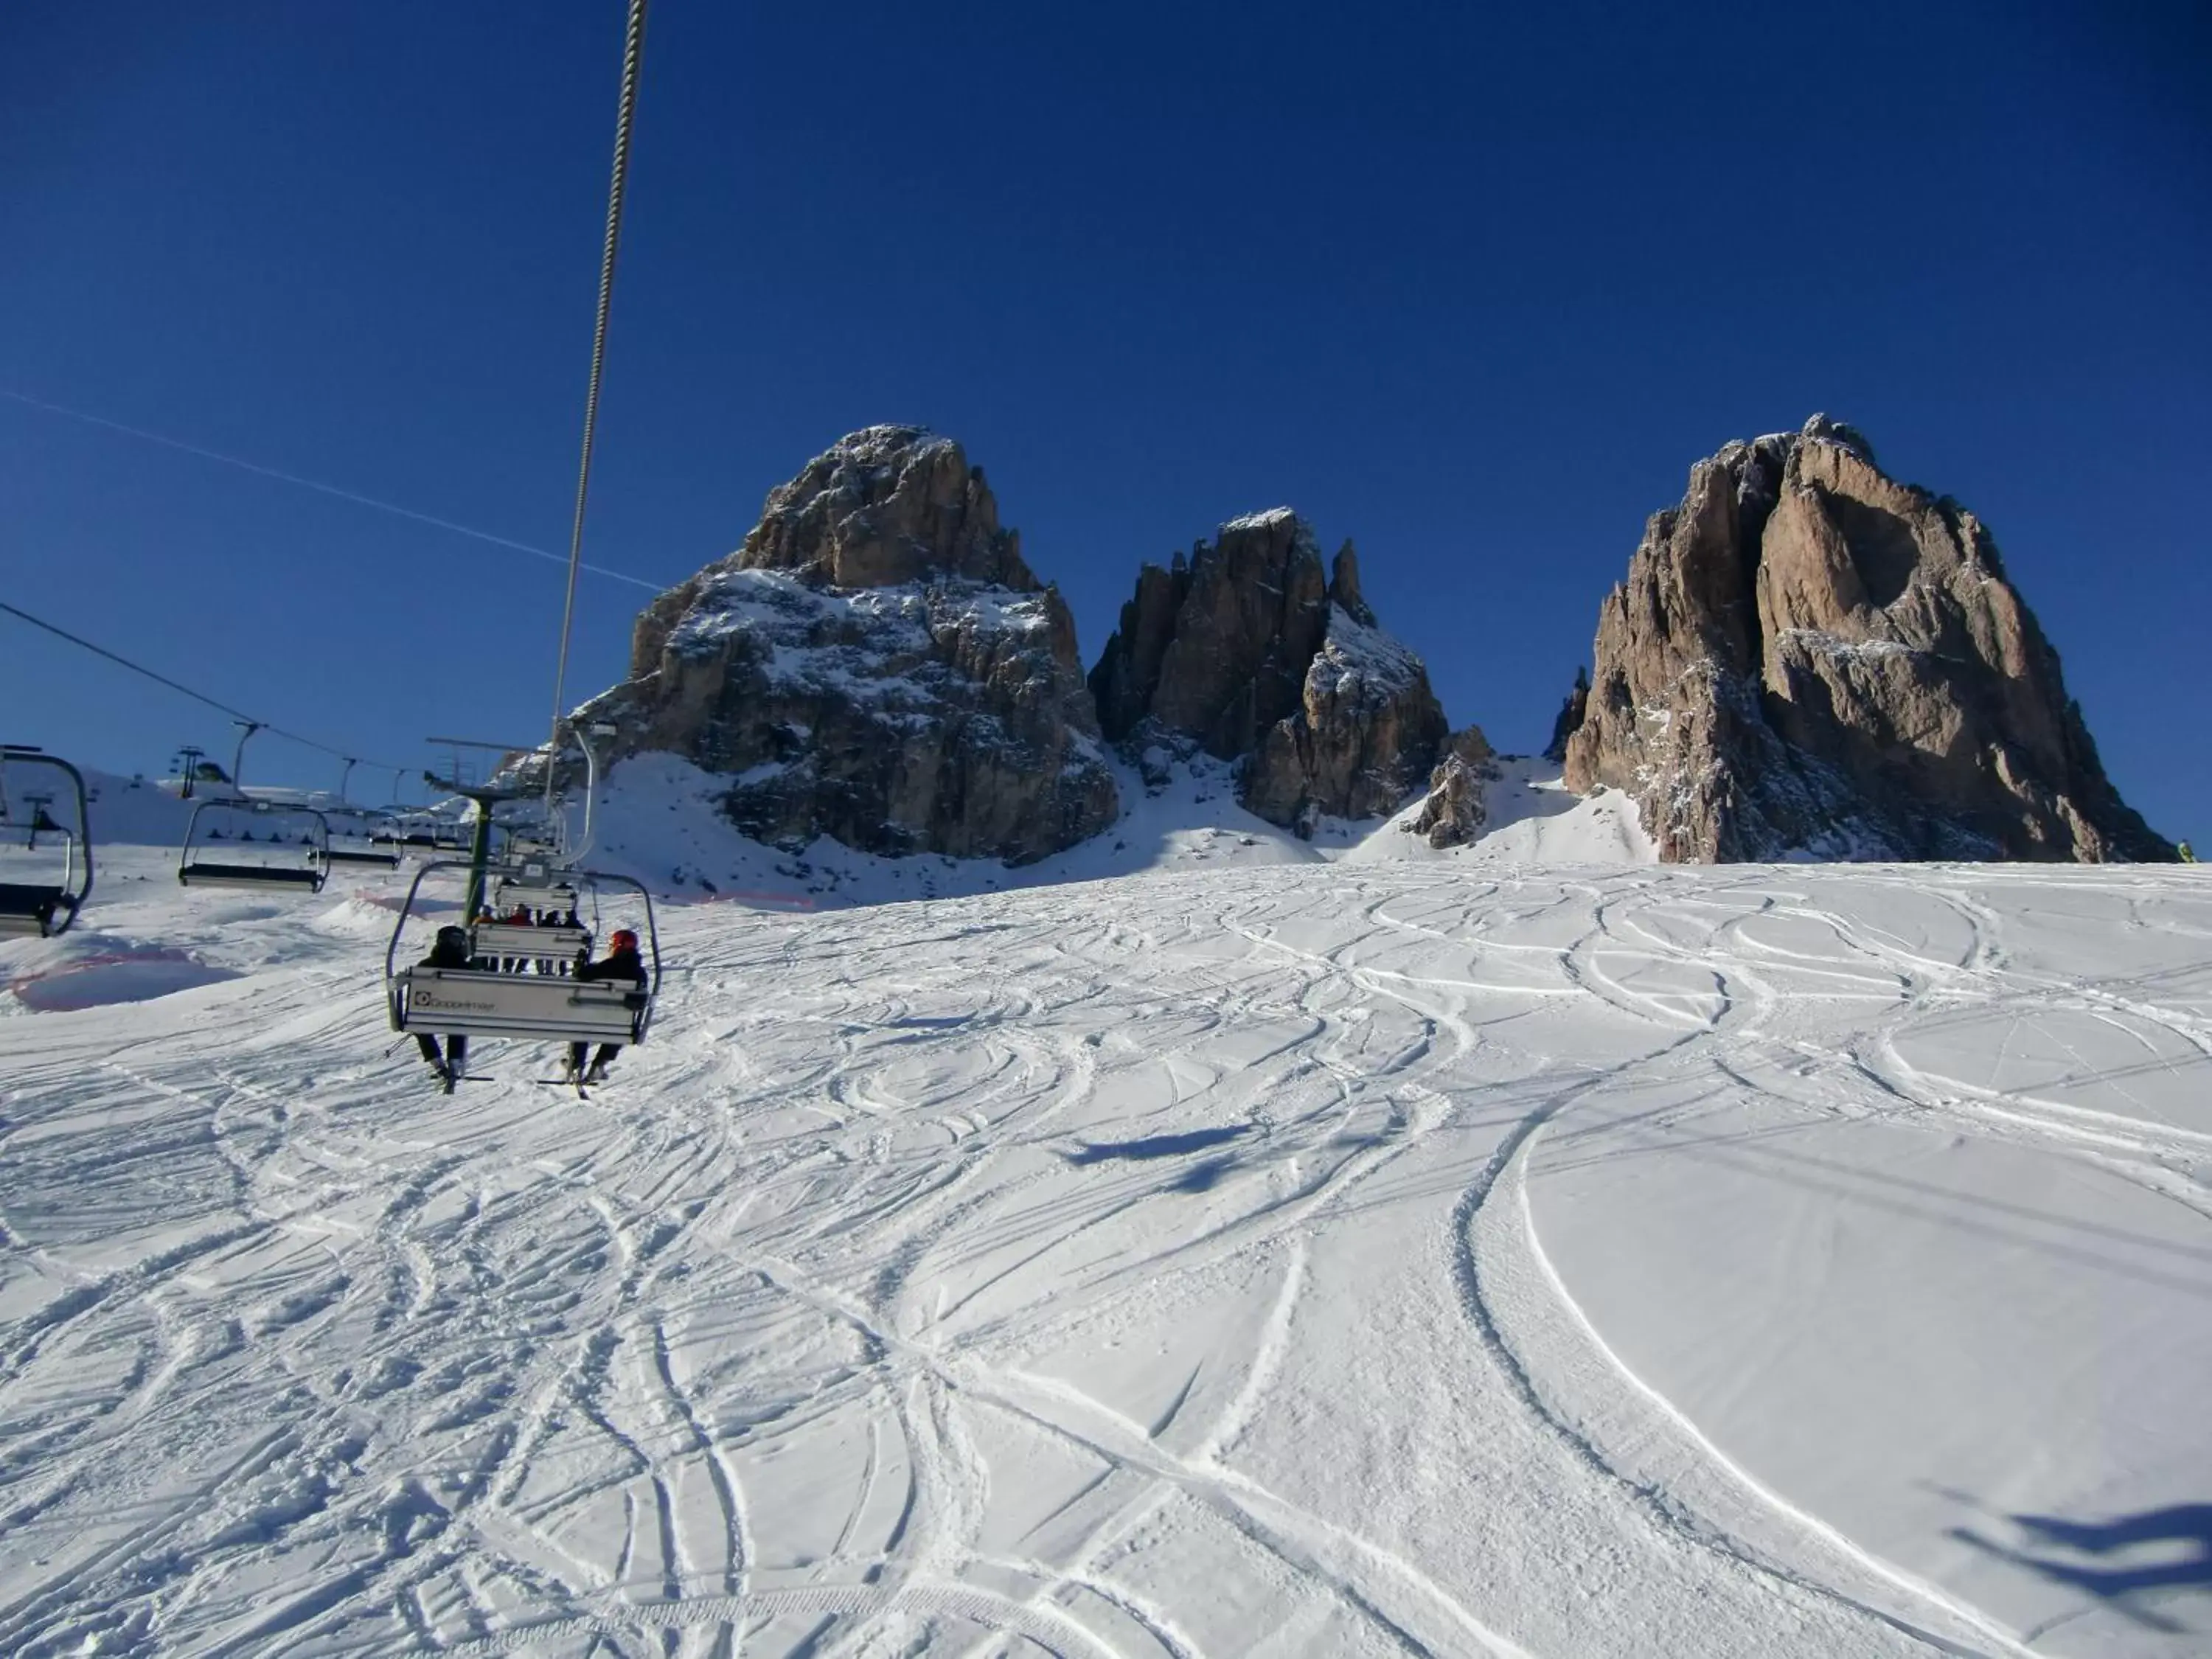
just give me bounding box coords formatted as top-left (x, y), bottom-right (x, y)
top-left (1566, 416), bottom-right (2174, 863)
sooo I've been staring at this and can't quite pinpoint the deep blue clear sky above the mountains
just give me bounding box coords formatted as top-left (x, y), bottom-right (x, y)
top-left (0, 0), bottom-right (2212, 838)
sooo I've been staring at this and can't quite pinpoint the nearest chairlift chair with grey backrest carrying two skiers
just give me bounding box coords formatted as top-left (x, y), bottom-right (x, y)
top-left (385, 858), bottom-right (661, 1044)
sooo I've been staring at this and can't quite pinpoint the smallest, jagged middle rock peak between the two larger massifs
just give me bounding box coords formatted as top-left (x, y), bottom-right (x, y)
top-left (1091, 507), bottom-right (1447, 825)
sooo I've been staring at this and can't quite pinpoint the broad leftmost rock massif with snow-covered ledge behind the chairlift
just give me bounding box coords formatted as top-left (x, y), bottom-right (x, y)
top-left (588, 427), bottom-right (1119, 863)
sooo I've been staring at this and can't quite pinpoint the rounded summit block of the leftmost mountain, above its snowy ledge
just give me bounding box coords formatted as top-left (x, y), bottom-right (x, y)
top-left (734, 427), bottom-right (1037, 593)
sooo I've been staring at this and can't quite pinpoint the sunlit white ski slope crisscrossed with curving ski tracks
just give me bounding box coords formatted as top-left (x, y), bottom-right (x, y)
top-left (0, 849), bottom-right (2212, 1659)
